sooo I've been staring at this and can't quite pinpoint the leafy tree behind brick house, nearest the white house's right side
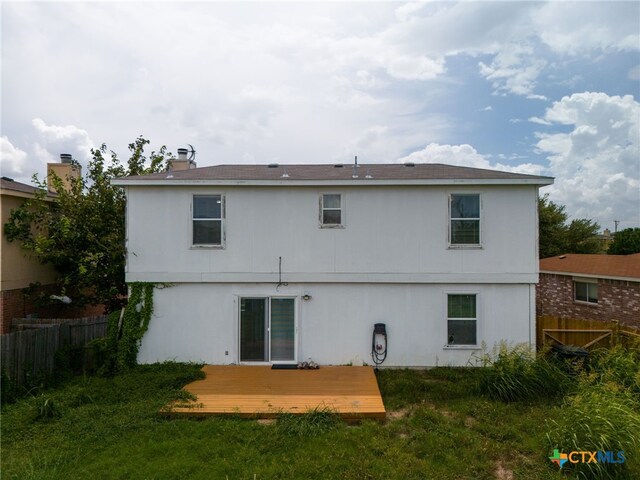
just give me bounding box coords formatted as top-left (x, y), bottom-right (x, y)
top-left (538, 195), bottom-right (601, 258)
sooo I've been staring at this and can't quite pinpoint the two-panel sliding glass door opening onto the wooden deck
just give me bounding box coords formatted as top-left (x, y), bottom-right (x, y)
top-left (240, 297), bottom-right (296, 362)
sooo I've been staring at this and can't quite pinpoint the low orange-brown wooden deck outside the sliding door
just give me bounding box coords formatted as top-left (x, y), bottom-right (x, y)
top-left (167, 365), bottom-right (386, 420)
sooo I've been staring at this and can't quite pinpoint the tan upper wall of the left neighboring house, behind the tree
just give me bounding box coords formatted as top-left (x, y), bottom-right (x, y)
top-left (0, 194), bottom-right (55, 290)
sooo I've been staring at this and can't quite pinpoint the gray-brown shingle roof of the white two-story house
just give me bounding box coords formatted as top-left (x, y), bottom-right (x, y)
top-left (120, 163), bottom-right (552, 184)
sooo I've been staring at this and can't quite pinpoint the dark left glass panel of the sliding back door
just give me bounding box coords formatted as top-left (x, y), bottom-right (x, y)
top-left (240, 298), bottom-right (269, 362)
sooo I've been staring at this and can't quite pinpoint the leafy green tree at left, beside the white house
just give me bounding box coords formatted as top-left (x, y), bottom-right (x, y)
top-left (5, 137), bottom-right (173, 311)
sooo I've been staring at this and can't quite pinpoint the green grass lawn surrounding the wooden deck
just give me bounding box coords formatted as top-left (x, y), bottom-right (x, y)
top-left (1, 363), bottom-right (592, 480)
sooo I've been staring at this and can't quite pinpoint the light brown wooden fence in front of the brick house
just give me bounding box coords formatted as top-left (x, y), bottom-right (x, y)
top-left (536, 315), bottom-right (640, 348)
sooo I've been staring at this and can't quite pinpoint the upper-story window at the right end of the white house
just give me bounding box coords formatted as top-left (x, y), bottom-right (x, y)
top-left (449, 193), bottom-right (480, 245)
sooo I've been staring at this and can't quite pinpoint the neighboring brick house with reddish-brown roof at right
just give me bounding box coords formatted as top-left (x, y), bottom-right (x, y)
top-left (536, 253), bottom-right (640, 327)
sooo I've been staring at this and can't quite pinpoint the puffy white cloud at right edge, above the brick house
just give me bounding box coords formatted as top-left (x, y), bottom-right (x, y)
top-left (536, 92), bottom-right (640, 227)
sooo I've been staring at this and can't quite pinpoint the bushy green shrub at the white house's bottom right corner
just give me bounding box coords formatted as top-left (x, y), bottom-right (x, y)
top-left (480, 344), bottom-right (574, 402)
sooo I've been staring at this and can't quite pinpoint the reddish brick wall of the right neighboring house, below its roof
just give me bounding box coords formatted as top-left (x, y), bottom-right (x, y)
top-left (536, 273), bottom-right (640, 327)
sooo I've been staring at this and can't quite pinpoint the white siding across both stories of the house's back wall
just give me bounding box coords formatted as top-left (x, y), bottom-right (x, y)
top-left (126, 185), bottom-right (538, 367)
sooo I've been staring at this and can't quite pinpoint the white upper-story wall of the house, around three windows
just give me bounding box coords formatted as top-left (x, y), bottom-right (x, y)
top-left (127, 185), bottom-right (538, 283)
